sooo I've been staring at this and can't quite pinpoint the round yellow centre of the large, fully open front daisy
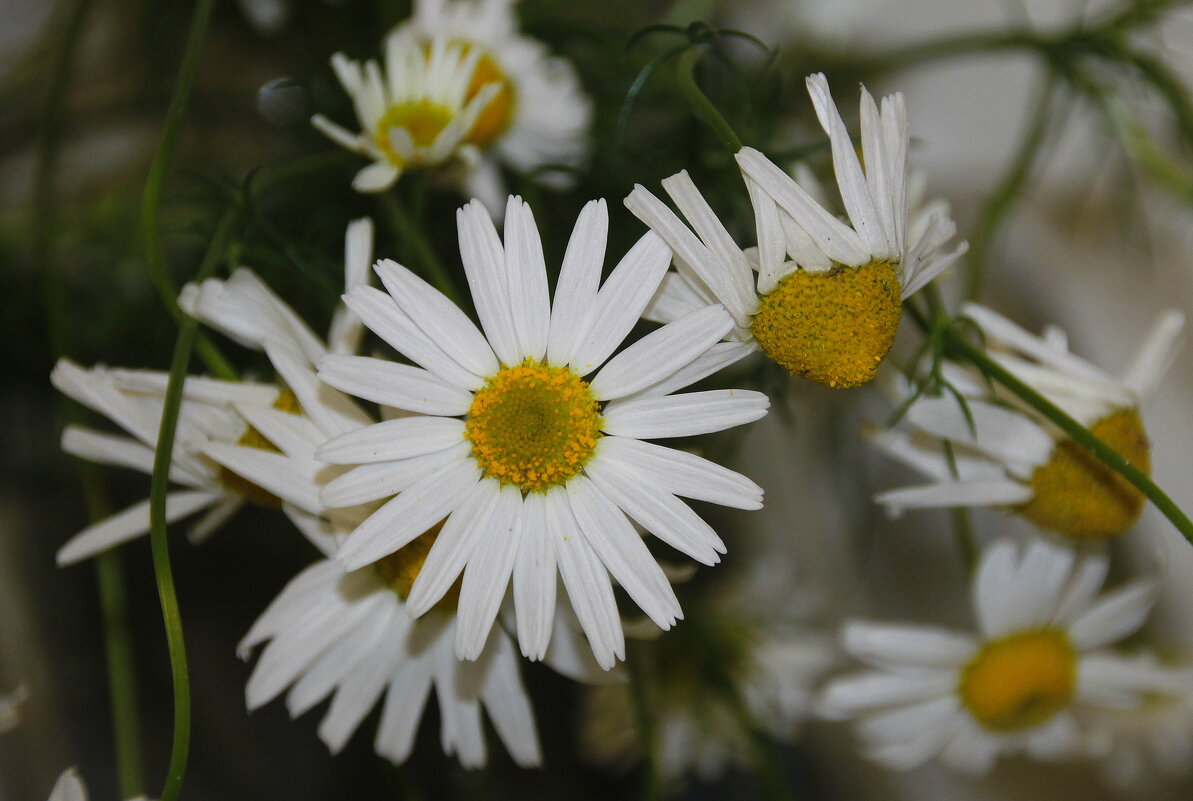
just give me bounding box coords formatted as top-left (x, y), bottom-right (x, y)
top-left (464, 359), bottom-right (601, 492)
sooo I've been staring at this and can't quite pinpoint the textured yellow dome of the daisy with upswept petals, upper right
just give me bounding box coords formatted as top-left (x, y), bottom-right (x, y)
top-left (750, 261), bottom-right (902, 387)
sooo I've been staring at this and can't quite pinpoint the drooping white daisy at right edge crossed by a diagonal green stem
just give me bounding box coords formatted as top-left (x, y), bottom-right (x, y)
top-left (870, 303), bottom-right (1185, 540)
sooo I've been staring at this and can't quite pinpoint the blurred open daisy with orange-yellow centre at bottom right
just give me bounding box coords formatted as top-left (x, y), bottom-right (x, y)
top-left (822, 540), bottom-right (1157, 774)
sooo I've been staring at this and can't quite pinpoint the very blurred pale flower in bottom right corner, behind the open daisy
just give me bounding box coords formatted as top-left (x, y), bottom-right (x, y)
top-left (1093, 653), bottom-right (1193, 787)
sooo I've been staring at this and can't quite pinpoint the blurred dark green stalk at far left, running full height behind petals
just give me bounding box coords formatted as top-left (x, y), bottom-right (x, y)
top-left (32, 0), bottom-right (143, 799)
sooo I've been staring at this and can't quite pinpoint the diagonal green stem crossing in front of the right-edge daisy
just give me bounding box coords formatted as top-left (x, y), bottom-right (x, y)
top-left (944, 328), bottom-right (1193, 544)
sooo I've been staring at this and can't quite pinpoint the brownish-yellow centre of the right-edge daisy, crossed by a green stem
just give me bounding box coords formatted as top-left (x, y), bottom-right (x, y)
top-left (1019, 408), bottom-right (1151, 540)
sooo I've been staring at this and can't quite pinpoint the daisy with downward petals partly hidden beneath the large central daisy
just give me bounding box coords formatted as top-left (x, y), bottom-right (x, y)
top-left (237, 520), bottom-right (542, 768)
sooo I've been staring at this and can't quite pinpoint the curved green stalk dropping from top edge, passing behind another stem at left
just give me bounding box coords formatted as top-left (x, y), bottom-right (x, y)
top-left (141, 0), bottom-right (237, 380)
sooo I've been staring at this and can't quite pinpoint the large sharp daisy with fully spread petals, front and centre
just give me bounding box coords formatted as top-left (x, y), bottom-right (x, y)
top-left (317, 197), bottom-right (768, 668)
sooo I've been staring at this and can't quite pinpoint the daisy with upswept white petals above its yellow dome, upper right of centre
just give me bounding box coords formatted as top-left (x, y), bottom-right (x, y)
top-left (625, 74), bottom-right (966, 387)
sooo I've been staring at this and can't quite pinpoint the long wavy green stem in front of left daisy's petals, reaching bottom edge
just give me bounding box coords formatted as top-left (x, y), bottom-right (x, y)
top-left (149, 208), bottom-right (239, 801)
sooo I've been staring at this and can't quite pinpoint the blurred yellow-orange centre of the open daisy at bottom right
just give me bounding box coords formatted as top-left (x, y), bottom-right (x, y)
top-left (958, 629), bottom-right (1077, 732)
